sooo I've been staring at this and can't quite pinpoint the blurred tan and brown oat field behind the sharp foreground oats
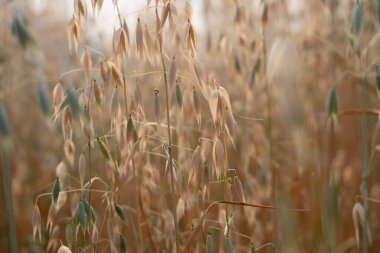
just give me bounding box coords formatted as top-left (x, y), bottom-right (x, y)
top-left (0, 0), bottom-right (380, 252)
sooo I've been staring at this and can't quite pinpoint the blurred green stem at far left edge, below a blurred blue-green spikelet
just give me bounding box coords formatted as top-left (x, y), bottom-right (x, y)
top-left (2, 147), bottom-right (17, 253)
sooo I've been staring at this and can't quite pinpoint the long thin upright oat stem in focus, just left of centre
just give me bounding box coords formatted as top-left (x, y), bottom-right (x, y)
top-left (160, 40), bottom-right (179, 253)
